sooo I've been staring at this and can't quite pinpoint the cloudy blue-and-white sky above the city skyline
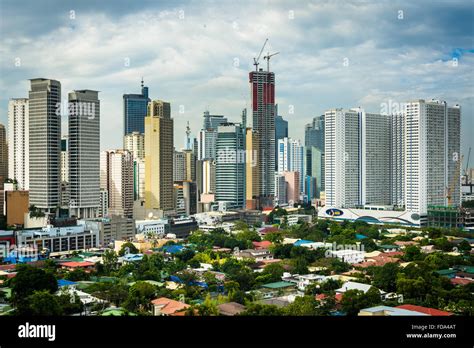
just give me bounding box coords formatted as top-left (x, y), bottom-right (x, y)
top-left (0, 0), bottom-right (474, 163)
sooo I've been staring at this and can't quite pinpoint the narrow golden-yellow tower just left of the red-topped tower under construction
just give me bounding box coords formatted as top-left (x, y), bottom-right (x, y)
top-left (245, 128), bottom-right (260, 209)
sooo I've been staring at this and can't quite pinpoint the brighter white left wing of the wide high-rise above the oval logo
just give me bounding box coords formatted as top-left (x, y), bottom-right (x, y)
top-left (324, 109), bottom-right (360, 208)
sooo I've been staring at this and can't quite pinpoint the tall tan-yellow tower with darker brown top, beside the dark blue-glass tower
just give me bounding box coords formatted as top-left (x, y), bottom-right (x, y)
top-left (145, 100), bottom-right (174, 213)
